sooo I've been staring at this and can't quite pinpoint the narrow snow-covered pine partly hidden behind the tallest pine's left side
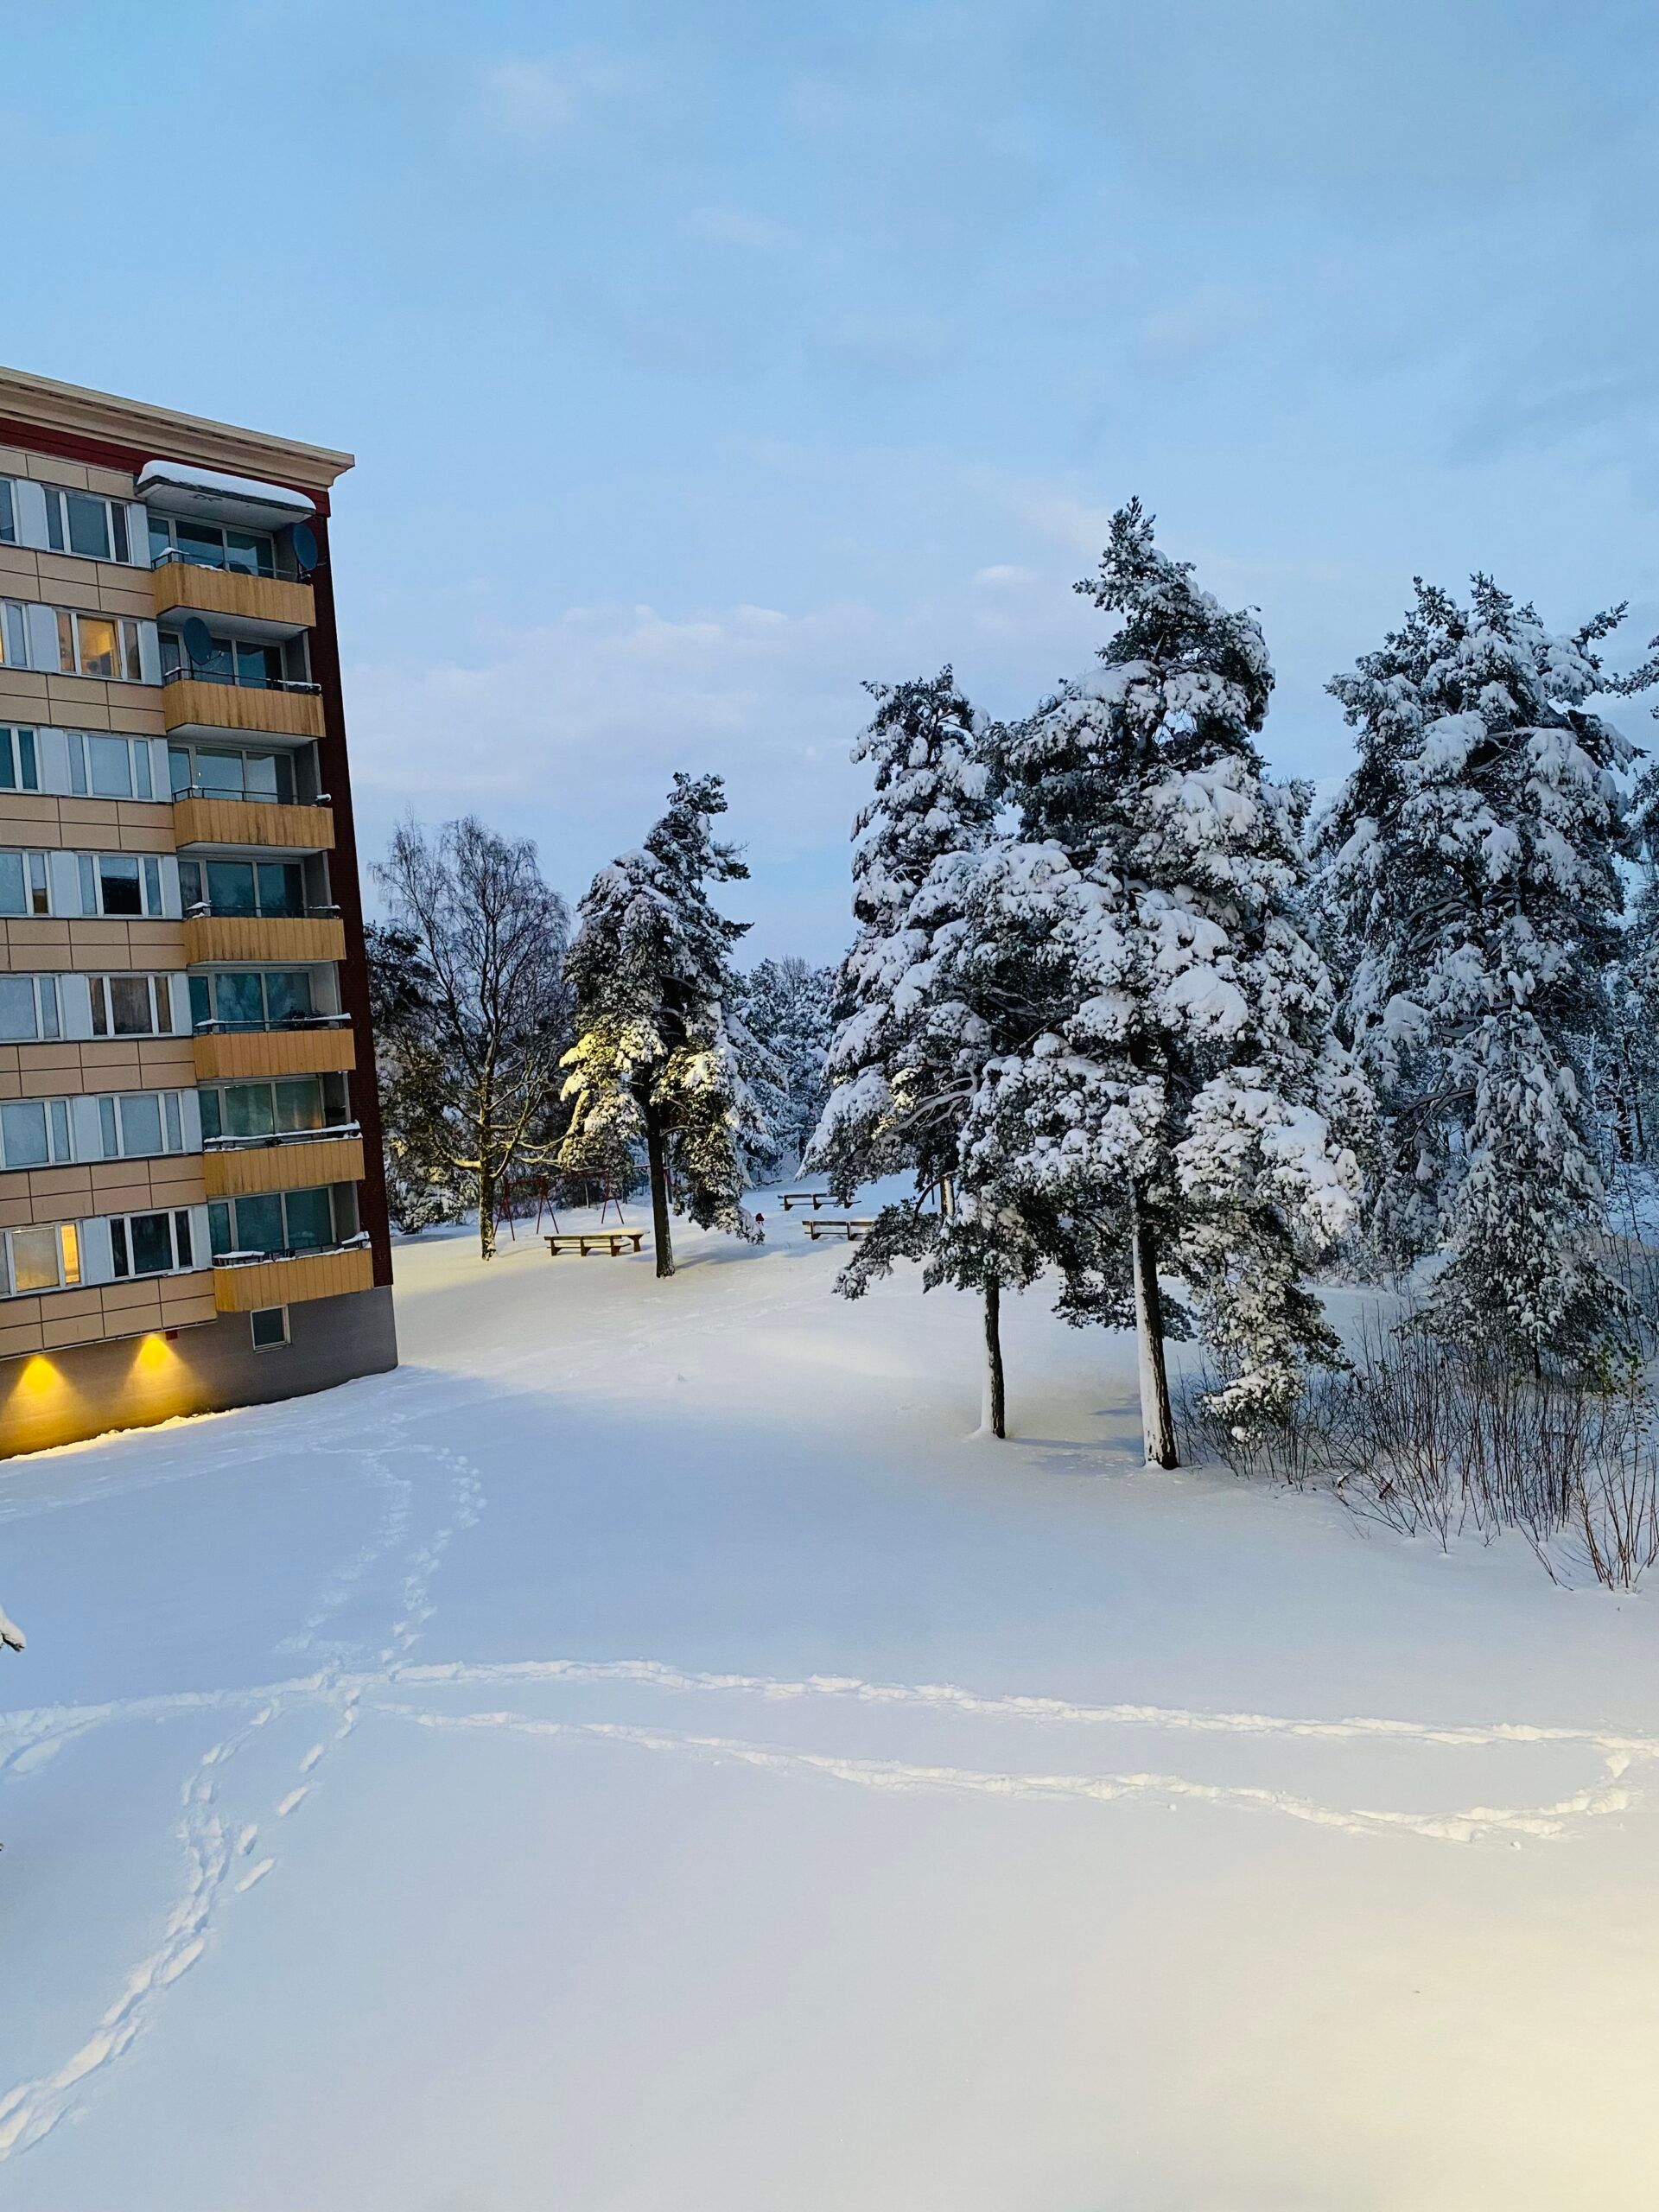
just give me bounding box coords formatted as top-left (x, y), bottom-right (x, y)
top-left (807, 668), bottom-right (1042, 1435)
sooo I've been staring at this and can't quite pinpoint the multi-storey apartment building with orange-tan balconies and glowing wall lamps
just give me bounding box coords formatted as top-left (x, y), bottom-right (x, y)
top-left (0, 370), bottom-right (396, 1455)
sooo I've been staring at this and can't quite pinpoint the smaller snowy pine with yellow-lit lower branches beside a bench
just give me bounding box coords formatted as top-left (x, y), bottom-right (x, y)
top-left (560, 774), bottom-right (772, 1276)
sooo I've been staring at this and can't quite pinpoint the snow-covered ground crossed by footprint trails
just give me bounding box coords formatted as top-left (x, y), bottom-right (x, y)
top-left (0, 1204), bottom-right (1659, 2212)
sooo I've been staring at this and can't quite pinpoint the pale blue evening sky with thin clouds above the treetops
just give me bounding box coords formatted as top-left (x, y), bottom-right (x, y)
top-left (0, 0), bottom-right (1659, 957)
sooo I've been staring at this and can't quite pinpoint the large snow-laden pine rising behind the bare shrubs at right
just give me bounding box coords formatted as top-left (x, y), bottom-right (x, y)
top-left (1319, 575), bottom-right (1632, 1363)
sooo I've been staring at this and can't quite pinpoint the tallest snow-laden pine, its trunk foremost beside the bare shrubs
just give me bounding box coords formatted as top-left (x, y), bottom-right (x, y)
top-left (973, 500), bottom-right (1360, 1466)
